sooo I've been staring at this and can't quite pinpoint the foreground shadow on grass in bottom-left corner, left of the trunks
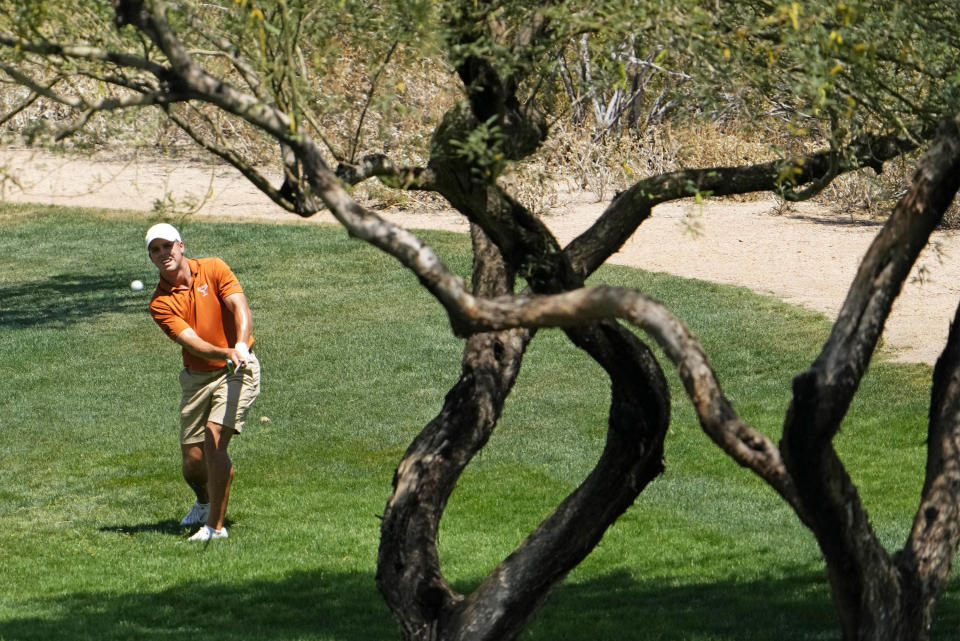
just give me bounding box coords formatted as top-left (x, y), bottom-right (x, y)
top-left (0, 570), bottom-right (399, 641)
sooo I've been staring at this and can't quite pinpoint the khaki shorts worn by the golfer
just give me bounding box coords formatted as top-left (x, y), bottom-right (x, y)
top-left (180, 353), bottom-right (260, 445)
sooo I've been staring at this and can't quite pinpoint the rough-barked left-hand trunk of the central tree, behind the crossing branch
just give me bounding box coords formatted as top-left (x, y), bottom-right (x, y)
top-left (376, 226), bottom-right (533, 640)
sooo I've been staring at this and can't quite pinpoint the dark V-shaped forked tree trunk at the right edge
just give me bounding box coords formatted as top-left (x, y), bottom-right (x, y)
top-left (781, 119), bottom-right (960, 641)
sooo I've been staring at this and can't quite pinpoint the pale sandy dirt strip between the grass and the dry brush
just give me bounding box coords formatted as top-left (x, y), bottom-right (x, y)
top-left (0, 149), bottom-right (960, 364)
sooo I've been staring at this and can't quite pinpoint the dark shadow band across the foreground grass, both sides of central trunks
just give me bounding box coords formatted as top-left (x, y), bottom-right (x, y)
top-left (0, 570), bottom-right (839, 641)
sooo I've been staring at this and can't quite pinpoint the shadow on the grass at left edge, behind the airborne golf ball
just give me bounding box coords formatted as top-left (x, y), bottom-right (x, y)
top-left (0, 271), bottom-right (146, 329)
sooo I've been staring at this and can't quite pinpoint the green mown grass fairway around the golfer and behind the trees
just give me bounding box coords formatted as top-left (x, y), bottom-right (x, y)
top-left (0, 205), bottom-right (960, 641)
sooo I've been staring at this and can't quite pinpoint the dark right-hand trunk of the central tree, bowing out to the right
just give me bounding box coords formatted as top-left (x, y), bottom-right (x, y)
top-left (443, 316), bottom-right (669, 641)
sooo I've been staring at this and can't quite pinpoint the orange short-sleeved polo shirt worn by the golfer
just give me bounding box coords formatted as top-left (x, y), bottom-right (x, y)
top-left (150, 258), bottom-right (253, 372)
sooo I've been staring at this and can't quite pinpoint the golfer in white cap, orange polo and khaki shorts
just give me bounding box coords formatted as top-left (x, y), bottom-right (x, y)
top-left (147, 223), bottom-right (260, 541)
